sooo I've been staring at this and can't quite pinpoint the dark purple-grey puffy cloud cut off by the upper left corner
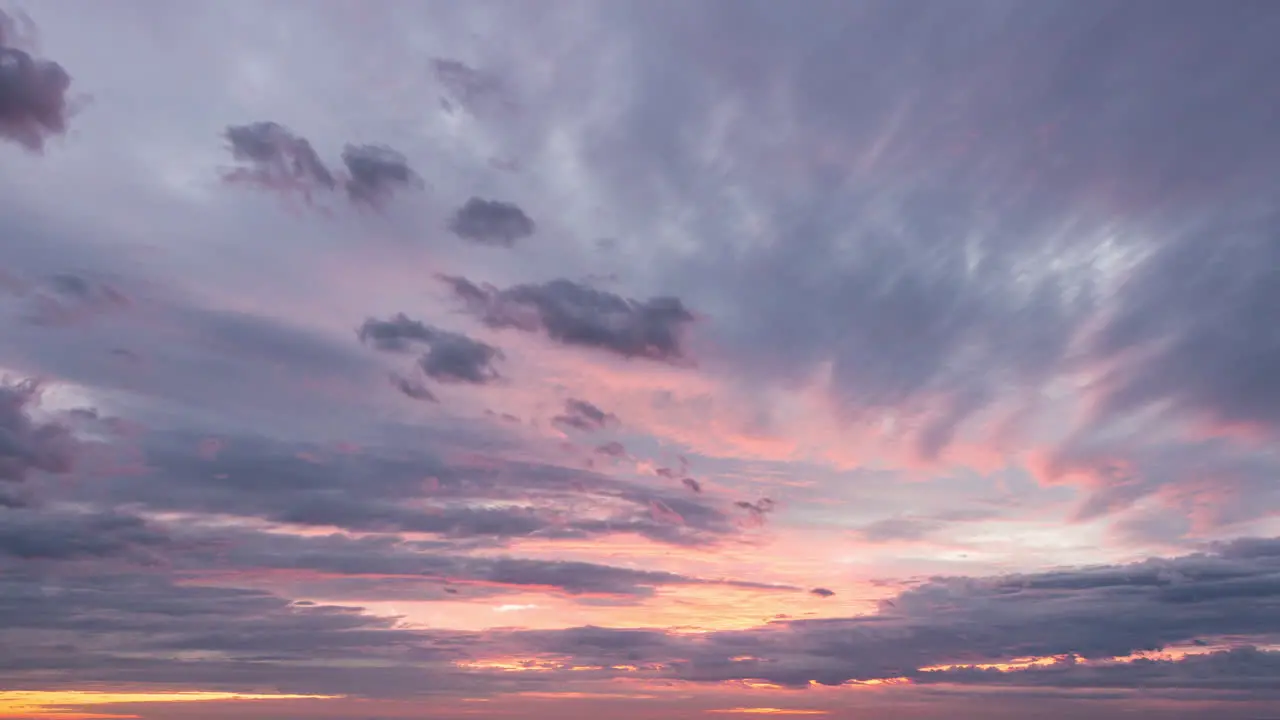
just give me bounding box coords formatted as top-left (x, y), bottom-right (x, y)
top-left (0, 10), bottom-right (72, 152)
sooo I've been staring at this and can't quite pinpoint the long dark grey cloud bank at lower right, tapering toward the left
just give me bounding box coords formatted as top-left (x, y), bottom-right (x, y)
top-left (512, 538), bottom-right (1280, 687)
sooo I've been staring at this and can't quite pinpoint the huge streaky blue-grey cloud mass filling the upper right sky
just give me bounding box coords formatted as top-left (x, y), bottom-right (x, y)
top-left (504, 3), bottom-right (1280, 459)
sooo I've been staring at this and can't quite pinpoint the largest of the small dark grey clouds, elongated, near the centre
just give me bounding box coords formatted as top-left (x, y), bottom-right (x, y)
top-left (440, 275), bottom-right (694, 363)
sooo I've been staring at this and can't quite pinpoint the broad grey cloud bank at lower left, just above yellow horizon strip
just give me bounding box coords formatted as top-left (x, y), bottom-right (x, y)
top-left (0, 571), bottom-right (494, 697)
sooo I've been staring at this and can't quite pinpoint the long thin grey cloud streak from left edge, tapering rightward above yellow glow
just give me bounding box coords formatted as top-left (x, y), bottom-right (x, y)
top-left (0, 497), bottom-right (797, 600)
